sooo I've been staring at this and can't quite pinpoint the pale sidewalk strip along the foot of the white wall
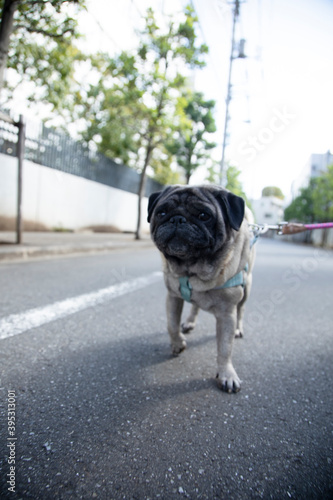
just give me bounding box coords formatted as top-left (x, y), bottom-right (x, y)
top-left (0, 231), bottom-right (153, 262)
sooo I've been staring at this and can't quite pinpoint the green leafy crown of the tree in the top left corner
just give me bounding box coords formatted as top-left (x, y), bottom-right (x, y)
top-left (0, 0), bottom-right (85, 109)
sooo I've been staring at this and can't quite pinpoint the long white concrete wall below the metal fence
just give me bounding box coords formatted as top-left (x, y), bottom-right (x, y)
top-left (0, 154), bottom-right (149, 232)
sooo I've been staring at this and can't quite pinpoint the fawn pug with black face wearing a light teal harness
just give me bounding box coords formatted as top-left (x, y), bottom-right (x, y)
top-left (148, 185), bottom-right (255, 393)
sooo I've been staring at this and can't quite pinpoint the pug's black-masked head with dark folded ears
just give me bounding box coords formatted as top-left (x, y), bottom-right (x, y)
top-left (148, 186), bottom-right (244, 261)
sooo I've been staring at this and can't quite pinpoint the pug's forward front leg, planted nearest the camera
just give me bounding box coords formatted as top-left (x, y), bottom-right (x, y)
top-left (216, 306), bottom-right (241, 393)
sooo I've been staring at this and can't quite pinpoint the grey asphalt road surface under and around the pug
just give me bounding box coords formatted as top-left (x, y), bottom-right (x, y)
top-left (0, 239), bottom-right (333, 500)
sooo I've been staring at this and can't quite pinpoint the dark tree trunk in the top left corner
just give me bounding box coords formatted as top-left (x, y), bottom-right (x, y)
top-left (0, 0), bottom-right (20, 93)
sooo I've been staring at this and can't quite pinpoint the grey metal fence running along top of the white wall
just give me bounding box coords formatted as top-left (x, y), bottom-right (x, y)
top-left (0, 116), bottom-right (161, 196)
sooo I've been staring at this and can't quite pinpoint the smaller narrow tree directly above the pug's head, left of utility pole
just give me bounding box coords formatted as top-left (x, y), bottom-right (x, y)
top-left (167, 91), bottom-right (216, 184)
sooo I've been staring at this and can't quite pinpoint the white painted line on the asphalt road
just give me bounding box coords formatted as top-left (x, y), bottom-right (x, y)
top-left (0, 271), bottom-right (162, 340)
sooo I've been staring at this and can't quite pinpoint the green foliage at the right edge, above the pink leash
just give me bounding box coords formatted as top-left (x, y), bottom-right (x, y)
top-left (284, 166), bottom-right (333, 223)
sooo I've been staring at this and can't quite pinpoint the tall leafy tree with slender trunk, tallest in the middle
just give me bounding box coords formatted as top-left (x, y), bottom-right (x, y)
top-left (82, 7), bottom-right (208, 239)
